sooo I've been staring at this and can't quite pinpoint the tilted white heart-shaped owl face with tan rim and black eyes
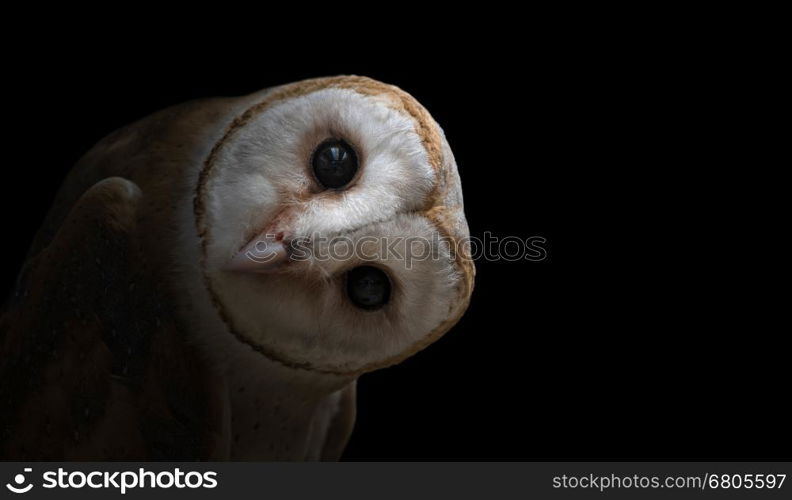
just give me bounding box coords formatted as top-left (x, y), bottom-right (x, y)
top-left (195, 77), bottom-right (473, 374)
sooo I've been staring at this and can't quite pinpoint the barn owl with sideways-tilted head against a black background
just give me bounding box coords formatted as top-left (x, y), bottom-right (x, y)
top-left (0, 76), bottom-right (474, 460)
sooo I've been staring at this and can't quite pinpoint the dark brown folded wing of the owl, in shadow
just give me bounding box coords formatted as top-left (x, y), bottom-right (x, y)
top-left (0, 177), bottom-right (228, 460)
